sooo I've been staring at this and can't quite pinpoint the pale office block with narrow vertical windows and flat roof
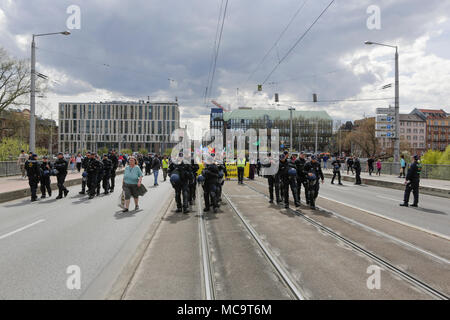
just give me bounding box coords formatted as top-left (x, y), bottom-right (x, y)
top-left (58, 100), bottom-right (180, 153)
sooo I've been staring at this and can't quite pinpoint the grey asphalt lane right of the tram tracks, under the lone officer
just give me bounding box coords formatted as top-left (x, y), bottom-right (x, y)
top-left (316, 179), bottom-right (450, 237)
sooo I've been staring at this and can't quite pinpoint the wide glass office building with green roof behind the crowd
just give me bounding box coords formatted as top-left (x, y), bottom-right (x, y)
top-left (210, 108), bottom-right (333, 152)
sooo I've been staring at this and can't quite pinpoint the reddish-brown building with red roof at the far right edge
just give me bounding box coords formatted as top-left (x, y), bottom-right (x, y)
top-left (411, 108), bottom-right (450, 151)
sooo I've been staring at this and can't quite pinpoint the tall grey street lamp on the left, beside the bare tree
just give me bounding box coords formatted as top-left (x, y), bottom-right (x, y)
top-left (30, 31), bottom-right (70, 152)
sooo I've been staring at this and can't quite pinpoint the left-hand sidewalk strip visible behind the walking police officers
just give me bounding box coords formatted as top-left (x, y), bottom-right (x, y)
top-left (0, 169), bottom-right (123, 203)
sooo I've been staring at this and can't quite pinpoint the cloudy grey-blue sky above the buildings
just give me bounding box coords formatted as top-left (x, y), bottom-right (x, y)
top-left (0, 0), bottom-right (450, 136)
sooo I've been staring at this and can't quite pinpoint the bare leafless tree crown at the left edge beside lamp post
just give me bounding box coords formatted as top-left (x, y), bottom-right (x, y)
top-left (0, 48), bottom-right (31, 112)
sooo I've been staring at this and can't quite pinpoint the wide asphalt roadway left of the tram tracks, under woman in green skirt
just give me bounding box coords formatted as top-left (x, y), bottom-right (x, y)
top-left (0, 176), bottom-right (173, 299)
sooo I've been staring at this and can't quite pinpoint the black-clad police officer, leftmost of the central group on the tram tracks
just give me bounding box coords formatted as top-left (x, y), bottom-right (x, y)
top-left (168, 152), bottom-right (192, 214)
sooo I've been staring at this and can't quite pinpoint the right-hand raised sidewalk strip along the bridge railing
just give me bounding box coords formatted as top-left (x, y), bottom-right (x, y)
top-left (322, 169), bottom-right (450, 198)
